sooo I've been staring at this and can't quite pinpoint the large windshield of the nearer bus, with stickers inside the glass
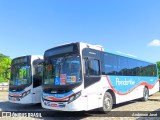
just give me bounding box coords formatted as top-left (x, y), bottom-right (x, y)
top-left (43, 55), bottom-right (81, 86)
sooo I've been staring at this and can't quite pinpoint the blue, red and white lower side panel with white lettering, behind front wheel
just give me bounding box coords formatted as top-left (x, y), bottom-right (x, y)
top-left (104, 76), bottom-right (159, 104)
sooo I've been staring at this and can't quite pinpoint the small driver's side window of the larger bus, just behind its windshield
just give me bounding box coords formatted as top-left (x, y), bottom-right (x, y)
top-left (88, 59), bottom-right (100, 76)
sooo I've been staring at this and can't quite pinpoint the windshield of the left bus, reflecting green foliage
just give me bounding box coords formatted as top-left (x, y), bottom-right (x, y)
top-left (10, 65), bottom-right (31, 86)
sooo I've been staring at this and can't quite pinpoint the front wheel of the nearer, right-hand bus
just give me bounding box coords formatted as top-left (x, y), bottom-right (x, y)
top-left (101, 92), bottom-right (113, 113)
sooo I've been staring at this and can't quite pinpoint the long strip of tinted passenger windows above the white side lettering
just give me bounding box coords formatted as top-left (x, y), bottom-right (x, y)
top-left (103, 53), bottom-right (157, 76)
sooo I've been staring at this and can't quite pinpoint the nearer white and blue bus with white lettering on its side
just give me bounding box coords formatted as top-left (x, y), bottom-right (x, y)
top-left (41, 42), bottom-right (159, 112)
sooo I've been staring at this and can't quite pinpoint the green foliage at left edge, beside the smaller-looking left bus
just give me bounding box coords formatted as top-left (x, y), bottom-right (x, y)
top-left (0, 54), bottom-right (12, 82)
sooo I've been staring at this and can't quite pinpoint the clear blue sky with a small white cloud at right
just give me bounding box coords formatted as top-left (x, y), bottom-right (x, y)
top-left (0, 0), bottom-right (160, 62)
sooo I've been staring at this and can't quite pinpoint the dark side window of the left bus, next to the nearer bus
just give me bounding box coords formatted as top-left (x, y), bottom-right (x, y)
top-left (33, 65), bottom-right (43, 87)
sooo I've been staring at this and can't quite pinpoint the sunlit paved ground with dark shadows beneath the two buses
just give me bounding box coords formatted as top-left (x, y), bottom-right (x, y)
top-left (0, 92), bottom-right (160, 120)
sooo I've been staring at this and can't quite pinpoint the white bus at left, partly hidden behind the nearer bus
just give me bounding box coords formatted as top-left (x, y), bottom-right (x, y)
top-left (8, 55), bottom-right (43, 104)
